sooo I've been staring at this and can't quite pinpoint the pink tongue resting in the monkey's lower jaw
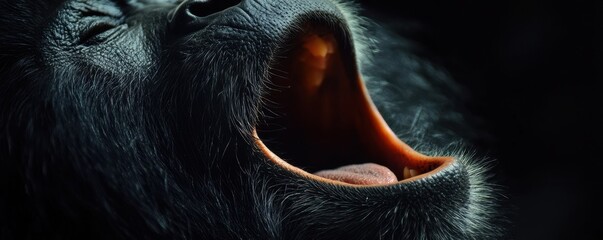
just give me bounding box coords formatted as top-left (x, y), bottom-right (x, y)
top-left (314, 163), bottom-right (398, 185)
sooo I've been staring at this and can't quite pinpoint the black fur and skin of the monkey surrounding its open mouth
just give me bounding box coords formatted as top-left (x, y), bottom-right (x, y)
top-left (0, 0), bottom-right (501, 239)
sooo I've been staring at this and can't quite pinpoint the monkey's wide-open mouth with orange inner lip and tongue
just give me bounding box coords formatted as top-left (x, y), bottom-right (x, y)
top-left (255, 24), bottom-right (453, 186)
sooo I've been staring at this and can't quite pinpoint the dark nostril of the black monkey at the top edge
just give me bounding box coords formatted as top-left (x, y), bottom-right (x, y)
top-left (168, 0), bottom-right (241, 31)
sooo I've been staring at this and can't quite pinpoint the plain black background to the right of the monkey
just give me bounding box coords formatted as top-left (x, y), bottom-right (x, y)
top-left (361, 0), bottom-right (603, 239)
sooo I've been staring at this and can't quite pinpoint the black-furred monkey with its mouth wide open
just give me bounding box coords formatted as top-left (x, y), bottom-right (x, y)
top-left (0, 0), bottom-right (501, 239)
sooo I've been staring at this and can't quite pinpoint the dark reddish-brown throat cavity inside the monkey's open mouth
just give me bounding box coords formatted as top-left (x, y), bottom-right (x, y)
top-left (258, 35), bottom-right (391, 179)
